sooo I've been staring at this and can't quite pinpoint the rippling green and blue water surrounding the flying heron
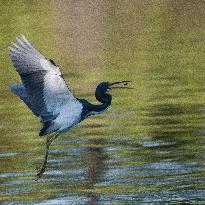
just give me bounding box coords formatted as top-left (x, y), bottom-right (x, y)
top-left (0, 0), bottom-right (205, 205)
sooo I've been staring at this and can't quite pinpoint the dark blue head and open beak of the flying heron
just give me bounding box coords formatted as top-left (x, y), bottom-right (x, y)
top-left (95, 80), bottom-right (130, 102)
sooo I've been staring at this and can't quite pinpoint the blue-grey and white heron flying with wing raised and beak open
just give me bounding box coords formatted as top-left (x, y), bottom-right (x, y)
top-left (9, 35), bottom-right (130, 179)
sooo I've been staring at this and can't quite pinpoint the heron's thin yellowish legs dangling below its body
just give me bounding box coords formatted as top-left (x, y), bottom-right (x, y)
top-left (36, 133), bottom-right (58, 179)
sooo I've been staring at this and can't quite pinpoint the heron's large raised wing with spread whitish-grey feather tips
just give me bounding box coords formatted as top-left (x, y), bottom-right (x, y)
top-left (9, 36), bottom-right (77, 125)
